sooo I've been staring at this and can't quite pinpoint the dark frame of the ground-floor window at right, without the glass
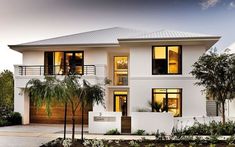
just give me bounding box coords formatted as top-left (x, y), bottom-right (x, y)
top-left (152, 88), bottom-right (183, 117)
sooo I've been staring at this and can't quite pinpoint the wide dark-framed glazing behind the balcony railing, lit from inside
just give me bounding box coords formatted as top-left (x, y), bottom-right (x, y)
top-left (44, 51), bottom-right (84, 75)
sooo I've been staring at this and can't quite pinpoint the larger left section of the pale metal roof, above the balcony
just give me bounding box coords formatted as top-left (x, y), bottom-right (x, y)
top-left (20, 27), bottom-right (146, 45)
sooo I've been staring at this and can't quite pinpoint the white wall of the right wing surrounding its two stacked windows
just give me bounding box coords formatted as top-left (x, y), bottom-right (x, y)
top-left (129, 46), bottom-right (206, 117)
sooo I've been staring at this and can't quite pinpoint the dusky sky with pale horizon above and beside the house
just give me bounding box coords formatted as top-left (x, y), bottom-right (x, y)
top-left (0, 0), bottom-right (235, 71)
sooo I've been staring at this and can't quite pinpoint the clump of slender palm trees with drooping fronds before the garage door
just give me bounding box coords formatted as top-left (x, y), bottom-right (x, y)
top-left (25, 75), bottom-right (104, 141)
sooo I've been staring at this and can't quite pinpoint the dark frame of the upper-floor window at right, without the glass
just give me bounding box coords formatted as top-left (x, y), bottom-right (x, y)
top-left (152, 45), bottom-right (183, 75)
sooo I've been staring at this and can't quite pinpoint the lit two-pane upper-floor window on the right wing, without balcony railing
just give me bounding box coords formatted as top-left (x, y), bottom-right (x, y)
top-left (152, 46), bottom-right (182, 75)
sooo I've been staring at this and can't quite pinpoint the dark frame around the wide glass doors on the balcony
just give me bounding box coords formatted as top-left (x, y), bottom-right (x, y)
top-left (44, 51), bottom-right (84, 75)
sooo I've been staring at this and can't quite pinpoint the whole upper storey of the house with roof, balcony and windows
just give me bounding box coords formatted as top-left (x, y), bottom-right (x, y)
top-left (10, 28), bottom-right (220, 85)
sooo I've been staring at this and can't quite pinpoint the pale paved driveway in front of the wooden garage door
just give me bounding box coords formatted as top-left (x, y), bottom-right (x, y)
top-left (0, 124), bottom-right (87, 147)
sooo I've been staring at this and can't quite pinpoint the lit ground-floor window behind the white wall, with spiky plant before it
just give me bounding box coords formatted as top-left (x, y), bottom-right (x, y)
top-left (152, 88), bottom-right (182, 116)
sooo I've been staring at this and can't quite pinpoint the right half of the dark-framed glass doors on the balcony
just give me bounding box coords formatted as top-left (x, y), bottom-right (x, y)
top-left (65, 52), bottom-right (83, 75)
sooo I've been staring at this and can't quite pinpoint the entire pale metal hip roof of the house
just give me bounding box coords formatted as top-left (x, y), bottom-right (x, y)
top-left (9, 27), bottom-right (220, 48)
